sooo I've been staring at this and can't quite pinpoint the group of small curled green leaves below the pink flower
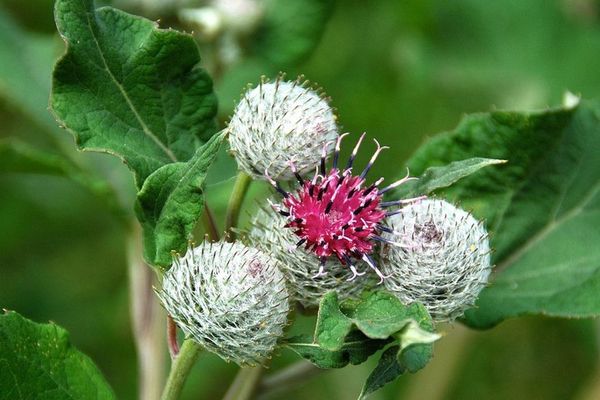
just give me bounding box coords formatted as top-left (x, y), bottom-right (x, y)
top-left (286, 291), bottom-right (439, 398)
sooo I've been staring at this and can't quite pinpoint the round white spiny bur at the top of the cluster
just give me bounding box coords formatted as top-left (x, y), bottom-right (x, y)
top-left (227, 77), bottom-right (338, 180)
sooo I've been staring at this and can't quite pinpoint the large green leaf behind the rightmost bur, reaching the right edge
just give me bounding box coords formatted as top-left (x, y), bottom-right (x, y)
top-left (400, 102), bottom-right (600, 328)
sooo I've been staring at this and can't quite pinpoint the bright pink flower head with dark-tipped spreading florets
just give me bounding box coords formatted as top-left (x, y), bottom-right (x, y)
top-left (265, 134), bottom-right (420, 283)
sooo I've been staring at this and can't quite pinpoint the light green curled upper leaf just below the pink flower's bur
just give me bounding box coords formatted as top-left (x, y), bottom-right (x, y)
top-left (315, 291), bottom-right (438, 351)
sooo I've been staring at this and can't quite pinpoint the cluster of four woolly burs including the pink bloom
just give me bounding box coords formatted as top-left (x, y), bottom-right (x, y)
top-left (158, 77), bottom-right (491, 365)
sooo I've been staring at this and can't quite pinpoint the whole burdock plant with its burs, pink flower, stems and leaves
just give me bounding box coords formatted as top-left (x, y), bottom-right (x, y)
top-left (5, 0), bottom-right (600, 400)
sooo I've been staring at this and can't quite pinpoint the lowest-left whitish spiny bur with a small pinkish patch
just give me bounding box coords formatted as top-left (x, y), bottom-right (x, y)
top-left (157, 242), bottom-right (289, 365)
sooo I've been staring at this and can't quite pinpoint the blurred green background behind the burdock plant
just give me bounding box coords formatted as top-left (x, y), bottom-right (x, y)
top-left (0, 0), bottom-right (600, 400)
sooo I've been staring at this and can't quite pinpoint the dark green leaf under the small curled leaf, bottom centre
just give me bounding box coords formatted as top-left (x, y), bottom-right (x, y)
top-left (285, 332), bottom-right (389, 368)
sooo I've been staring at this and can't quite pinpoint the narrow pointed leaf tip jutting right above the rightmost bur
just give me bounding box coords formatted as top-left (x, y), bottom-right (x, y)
top-left (393, 157), bottom-right (506, 198)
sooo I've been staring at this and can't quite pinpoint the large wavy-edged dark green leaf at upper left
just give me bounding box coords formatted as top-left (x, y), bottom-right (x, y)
top-left (50, 0), bottom-right (217, 188)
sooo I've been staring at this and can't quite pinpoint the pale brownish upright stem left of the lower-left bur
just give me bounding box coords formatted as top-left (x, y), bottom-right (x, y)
top-left (128, 223), bottom-right (165, 400)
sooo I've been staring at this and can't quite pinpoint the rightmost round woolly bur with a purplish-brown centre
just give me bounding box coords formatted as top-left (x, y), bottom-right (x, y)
top-left (381, 200), bottom-right (491, 321)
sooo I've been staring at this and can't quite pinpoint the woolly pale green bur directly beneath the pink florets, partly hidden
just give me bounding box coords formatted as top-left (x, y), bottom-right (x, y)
top-left (247, 208), bottom-right (371, 308)
